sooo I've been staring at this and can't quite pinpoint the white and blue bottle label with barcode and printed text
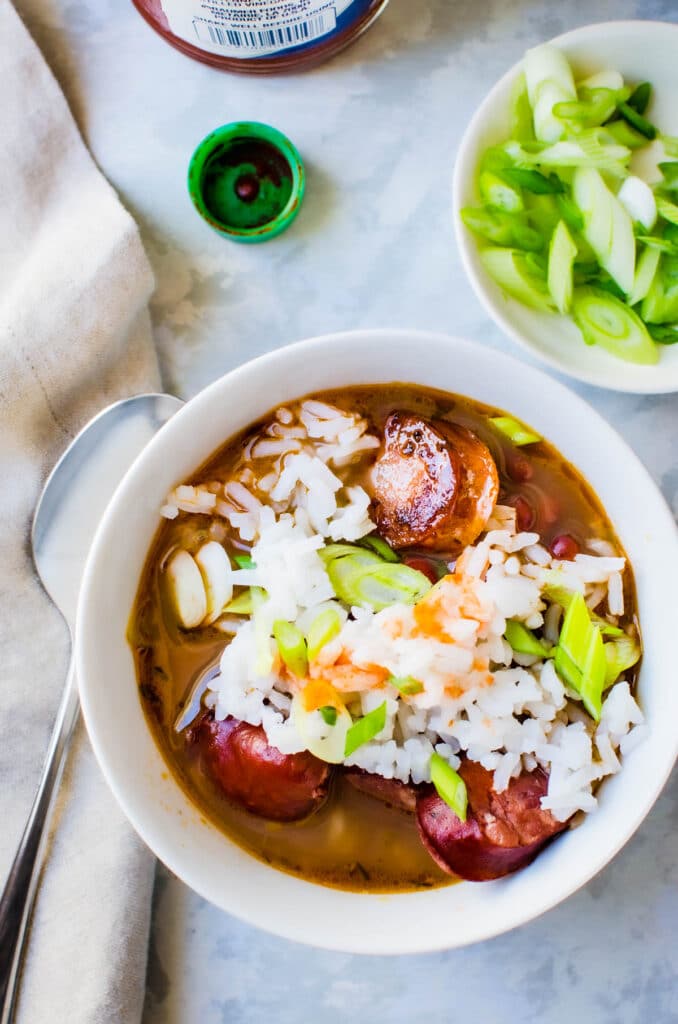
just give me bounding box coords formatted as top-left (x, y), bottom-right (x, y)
top-left (161, 0), bottom-right (373, 58)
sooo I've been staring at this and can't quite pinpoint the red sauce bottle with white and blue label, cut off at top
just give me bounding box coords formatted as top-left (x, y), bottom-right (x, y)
top-left (132, 0), bottom-right (388, 75)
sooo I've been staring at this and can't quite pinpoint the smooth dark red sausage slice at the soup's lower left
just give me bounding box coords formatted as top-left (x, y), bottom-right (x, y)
top-left (192, 715), bottom-right (330, 821)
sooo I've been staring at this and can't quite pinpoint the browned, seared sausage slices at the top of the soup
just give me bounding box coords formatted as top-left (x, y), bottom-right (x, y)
top-left (373, 413), bottom-right (499, 551)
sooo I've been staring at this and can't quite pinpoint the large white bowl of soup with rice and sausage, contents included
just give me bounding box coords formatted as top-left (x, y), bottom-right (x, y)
top-left (77, 331), bottom-right (678, 953)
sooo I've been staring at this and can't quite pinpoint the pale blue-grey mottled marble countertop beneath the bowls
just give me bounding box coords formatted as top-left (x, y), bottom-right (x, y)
top-left (17, 0), bottom-right (678, 1024)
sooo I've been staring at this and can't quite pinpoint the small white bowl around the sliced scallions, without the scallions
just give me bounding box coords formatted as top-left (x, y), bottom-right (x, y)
top-left (453, 22), bottom-right (678, 394)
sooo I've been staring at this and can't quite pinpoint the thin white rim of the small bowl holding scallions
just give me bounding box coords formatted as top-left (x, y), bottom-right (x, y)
top-left (452, 19), bottom-right (678, 394)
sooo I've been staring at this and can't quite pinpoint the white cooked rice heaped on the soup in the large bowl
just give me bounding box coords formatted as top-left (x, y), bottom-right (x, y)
top-left (162, 400), bottom-right (644, 820)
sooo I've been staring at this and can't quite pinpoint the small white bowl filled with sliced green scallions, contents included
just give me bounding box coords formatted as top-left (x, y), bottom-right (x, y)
top-left (454, 22), bottom-right (678, 393)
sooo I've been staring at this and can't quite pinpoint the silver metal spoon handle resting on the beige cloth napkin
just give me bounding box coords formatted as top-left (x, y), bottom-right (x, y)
top-left (0, 656), bottom-right (79, 1024)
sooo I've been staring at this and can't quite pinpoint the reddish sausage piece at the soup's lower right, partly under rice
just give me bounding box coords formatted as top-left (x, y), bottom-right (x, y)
top-left (417, 761), bottom-right (566, 882)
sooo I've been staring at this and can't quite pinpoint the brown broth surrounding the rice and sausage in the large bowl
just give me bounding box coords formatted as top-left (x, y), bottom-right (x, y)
top-left (129, 384), bottom-right (635, 892)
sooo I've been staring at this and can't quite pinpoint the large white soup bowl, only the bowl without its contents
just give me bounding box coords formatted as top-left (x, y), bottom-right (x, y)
top-left (77, 331), bottom-right (678, 953)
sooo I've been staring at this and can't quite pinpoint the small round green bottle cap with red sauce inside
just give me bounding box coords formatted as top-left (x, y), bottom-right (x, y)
top-left (188, 121), bottom-right (306, 242)
